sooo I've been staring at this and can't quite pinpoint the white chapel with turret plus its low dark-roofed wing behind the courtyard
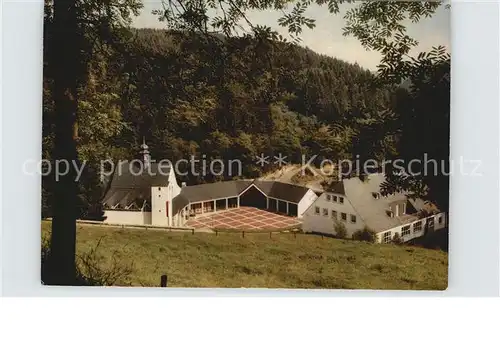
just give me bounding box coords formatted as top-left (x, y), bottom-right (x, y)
top-left (103, 143), bottom-right (318, 227)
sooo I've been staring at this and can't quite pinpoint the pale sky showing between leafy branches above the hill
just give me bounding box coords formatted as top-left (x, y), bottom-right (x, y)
top-left (133, 0), bottom-right (450, 70)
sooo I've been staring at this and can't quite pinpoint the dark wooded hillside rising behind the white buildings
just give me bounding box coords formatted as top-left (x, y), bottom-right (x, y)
top-left (44, 29), bottom-right (394, 166)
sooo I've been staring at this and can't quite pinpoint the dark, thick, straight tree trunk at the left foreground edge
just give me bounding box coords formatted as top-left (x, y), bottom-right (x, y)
top-left (48, 0), bottom-right (80, 285)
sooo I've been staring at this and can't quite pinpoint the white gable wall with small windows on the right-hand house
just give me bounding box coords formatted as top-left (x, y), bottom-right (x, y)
top-left (302, 192), bottom-right (364, 237)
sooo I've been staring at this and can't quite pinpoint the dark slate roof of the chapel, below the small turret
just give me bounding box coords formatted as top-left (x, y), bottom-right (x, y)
top-left (102, 162), bottom-right (170, 207)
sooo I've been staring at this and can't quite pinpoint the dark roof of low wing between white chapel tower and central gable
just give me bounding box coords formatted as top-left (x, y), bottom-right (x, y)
top-left (181, 180), bottom-right (252, 202)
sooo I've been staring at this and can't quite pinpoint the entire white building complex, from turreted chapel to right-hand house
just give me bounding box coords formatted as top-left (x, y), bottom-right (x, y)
top-left (99, 143), bottom-right (446, 243)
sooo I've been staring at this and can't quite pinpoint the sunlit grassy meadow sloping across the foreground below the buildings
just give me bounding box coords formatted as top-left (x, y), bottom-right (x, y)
top-left (42, 222), bottom-right (448, 290)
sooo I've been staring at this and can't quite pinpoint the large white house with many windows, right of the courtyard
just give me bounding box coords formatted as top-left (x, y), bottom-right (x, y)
top-left (302, 173), bottom-right (446, 243)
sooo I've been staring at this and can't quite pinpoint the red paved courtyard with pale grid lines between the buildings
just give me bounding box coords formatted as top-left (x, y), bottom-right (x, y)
top-left (186, 207), bottom-right (301, 230)
